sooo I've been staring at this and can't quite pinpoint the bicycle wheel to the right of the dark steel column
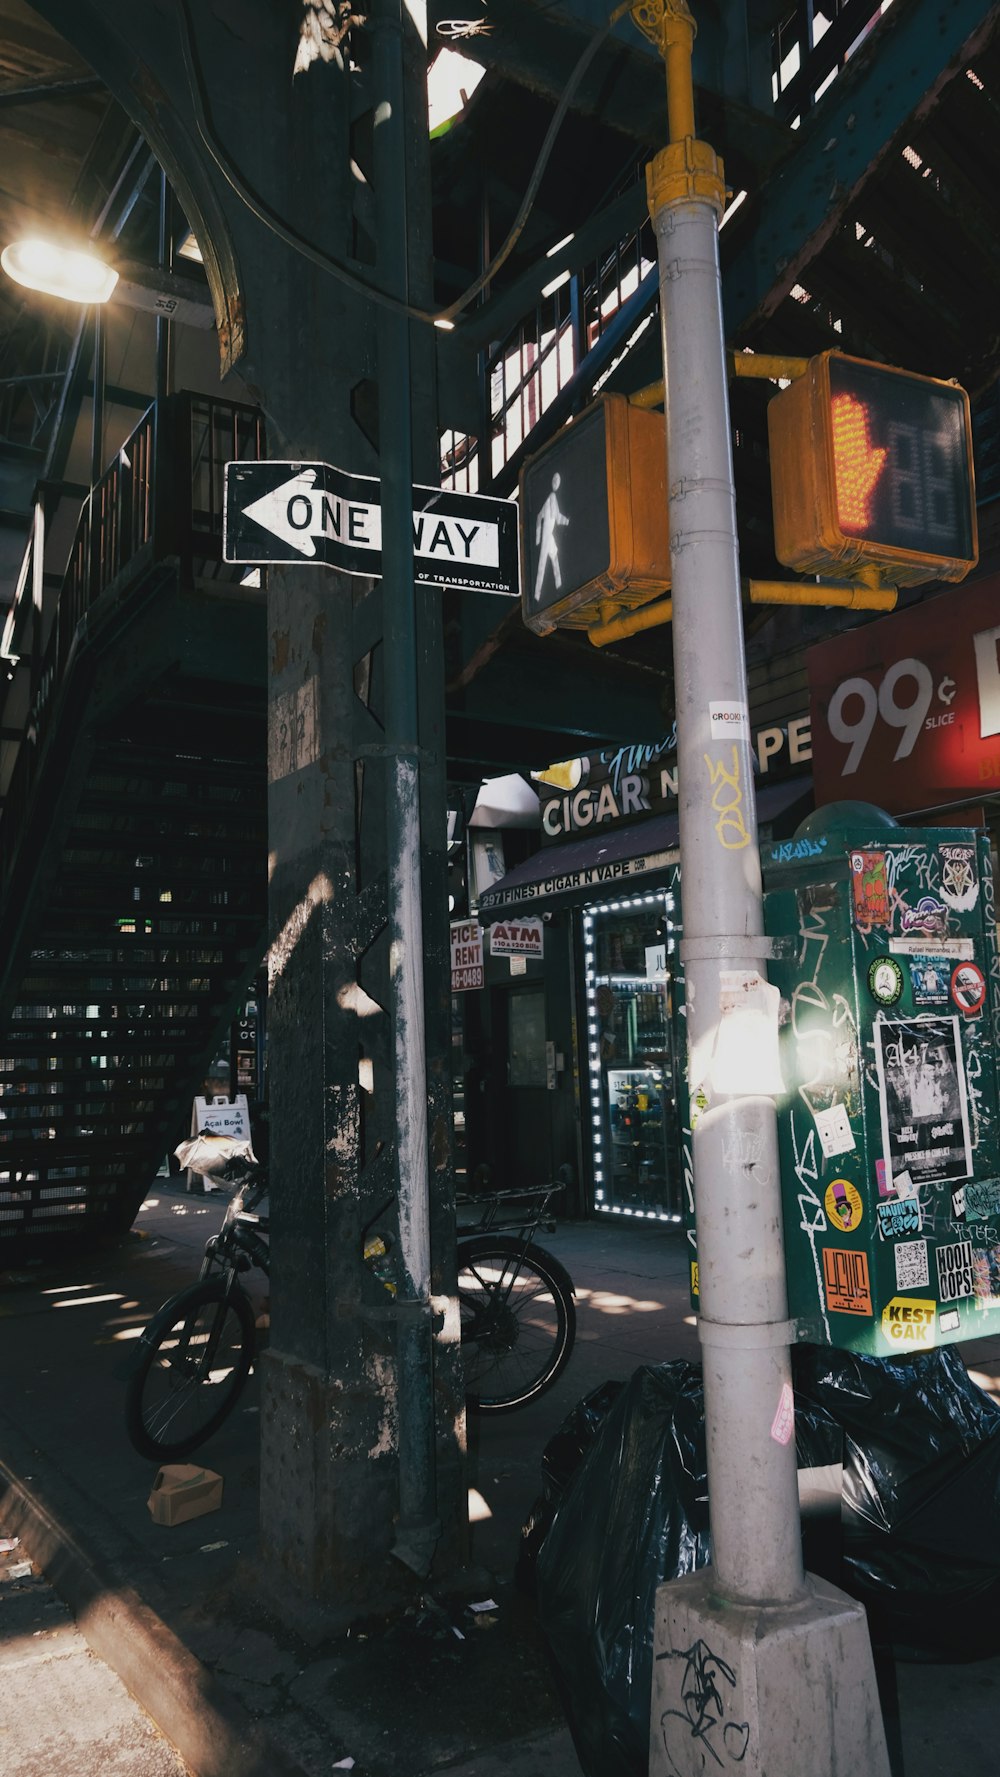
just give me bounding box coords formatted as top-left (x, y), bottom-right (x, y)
top-left (458, 1235), bottom-right (575, 1413)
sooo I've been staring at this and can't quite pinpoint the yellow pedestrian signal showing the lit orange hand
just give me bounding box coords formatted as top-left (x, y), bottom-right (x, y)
top-left (767, 352), bottom-right (979, 586)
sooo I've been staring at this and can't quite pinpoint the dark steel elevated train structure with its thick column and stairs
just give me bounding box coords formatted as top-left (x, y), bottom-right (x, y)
top-left (0, 0), bottom-right (1000, 1608)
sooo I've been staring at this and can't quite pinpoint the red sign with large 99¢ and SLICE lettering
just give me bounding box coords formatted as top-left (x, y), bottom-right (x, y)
top-left (806, 576), bottom-right (1000, 814)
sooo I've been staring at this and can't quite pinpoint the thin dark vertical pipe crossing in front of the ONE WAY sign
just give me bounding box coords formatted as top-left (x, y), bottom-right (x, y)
top-left (371, 0), bottom-right (440, 1574)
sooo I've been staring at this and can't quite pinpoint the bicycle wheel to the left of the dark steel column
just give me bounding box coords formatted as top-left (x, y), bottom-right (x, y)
top-left (124, 1278), bottom-right (256, 1462)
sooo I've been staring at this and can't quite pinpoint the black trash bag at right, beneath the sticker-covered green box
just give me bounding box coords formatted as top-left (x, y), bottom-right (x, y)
top-left (794, 1347), bottom-right (1000, 1660)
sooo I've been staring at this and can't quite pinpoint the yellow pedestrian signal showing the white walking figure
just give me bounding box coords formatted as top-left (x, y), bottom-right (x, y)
top-left (520, 394), bottom-right (670, 636)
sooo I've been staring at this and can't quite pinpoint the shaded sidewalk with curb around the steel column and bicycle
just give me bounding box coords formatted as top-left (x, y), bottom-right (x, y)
top-left (0, 1178), bottom-right (1000, 1777)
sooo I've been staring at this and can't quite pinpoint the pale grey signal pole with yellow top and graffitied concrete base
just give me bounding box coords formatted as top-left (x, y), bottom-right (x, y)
top-left (634, 0), bottom-right (888, 1777)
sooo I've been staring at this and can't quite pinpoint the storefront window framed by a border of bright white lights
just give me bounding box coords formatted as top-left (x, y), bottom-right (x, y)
top-left (584, 892), bottom-right (682, 1221)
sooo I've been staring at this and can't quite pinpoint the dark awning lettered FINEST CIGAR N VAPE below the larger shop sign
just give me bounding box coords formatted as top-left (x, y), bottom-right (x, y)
top-left (480, 778), bottom-right (812, 924)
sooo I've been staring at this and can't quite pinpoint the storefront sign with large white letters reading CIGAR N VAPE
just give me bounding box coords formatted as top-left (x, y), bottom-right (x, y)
top-left (538, 716), bottom-right (812, 844)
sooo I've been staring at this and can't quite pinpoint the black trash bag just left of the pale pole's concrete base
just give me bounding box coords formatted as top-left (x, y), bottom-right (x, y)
top-left (536, 1361), bottom-right (840, 1777)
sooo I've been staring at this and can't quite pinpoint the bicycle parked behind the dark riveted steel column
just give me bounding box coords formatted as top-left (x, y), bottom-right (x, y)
top-left (124, 1159), bottom-right (575, 1462)
